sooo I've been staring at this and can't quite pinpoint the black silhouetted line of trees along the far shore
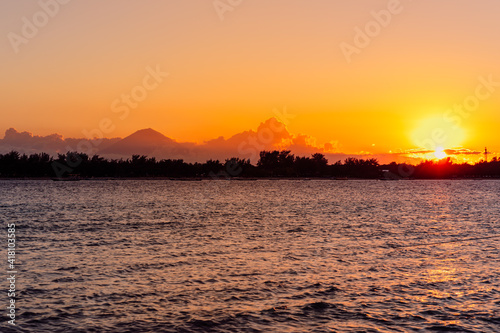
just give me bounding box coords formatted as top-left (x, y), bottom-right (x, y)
top-left (0, 150), bottom-right (500, 179)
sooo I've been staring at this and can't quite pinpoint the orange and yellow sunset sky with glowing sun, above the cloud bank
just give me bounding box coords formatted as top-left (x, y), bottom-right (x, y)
top-left (0, 0), bottom-right (500, 161)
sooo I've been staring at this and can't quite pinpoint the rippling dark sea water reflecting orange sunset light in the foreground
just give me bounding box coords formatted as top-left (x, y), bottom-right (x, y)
top-left (0, 180), bottom-right (500, 333)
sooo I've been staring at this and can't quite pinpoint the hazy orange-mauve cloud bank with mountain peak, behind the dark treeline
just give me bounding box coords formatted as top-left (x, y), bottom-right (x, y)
top-left (0, 117), bottom-right (488, 164)
